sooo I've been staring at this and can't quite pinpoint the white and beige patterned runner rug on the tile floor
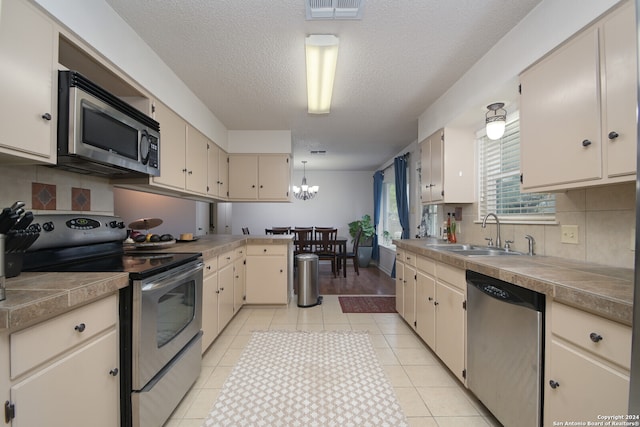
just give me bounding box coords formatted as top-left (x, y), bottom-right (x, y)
top-left (203, 331), bottom-right (407, 427)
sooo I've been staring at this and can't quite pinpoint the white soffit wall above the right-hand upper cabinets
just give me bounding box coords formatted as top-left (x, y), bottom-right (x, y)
top-left (418, 0), bottom-right (619, 137)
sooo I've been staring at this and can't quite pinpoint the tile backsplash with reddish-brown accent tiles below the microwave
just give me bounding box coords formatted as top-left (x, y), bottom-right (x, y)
top-left (0, 165), bottom-right (113, 215)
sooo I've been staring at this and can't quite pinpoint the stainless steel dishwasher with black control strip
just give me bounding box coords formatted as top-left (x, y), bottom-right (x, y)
top-left (467, 270), bottom-right (545, 427)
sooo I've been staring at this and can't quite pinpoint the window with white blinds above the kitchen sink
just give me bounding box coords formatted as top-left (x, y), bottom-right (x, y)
top-left (478, 113), bottom-right (556, 222)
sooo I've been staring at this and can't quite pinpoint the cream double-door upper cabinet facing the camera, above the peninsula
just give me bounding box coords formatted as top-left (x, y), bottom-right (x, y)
top-left (229, 154), bottom-right (291, 201)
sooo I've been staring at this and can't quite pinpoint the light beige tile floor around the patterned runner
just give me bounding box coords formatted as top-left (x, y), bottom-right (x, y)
top-left (165, 295), bottom-right (500, 427)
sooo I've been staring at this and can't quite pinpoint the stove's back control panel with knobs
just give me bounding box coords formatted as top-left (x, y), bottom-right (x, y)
top-left (29, 214), bottom-right (127, 251)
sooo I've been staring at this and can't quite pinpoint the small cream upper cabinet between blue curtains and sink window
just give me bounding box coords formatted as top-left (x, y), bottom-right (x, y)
top-left (420, 128), bottom-right (475, 203)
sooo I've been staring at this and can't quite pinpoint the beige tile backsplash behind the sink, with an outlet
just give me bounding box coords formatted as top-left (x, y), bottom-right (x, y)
top-left (444, 183), bottom-right (636, 268)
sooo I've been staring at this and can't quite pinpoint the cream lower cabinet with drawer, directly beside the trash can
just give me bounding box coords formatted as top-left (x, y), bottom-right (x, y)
top-left (246, 244), bottom-right (289, 304)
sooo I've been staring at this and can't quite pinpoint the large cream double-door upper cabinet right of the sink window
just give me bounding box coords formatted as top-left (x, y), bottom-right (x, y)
top-left (520, 2), bottom-right (637, 191)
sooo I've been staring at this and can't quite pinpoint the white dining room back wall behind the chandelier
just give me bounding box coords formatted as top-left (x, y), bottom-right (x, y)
top-left (232, 171), bottom-right (373, 246)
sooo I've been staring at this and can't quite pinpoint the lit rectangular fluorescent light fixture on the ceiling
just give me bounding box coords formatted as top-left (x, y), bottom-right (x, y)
top-left (305, 34), bottom-right (339, 114)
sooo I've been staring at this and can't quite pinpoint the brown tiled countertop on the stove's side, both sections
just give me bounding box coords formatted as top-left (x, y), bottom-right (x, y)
top-left (0, 235), bottom-right (293, 332)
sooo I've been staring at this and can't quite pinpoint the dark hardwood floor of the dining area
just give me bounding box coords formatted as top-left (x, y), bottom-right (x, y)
top-left (318, 262), bottom-right (396, 295)
